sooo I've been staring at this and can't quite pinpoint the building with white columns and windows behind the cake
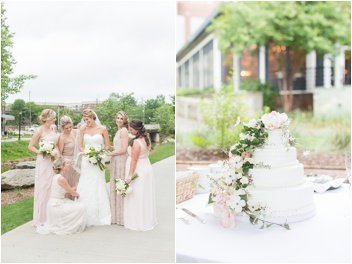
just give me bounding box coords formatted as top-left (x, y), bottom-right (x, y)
top-left (176, 3), bottom-right (351, 114)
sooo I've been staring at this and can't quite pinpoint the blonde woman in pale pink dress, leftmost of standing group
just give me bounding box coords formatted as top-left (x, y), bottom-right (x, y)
top-left (28, 109), bottom-right (58, 226)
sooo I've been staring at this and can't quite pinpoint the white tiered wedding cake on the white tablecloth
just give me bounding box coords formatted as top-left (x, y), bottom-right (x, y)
top-left (249, 128), bottom-right (315, 223)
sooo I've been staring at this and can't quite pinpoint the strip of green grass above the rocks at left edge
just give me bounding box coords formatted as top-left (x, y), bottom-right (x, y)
top-left (1, 140), bottom-right (35, 162)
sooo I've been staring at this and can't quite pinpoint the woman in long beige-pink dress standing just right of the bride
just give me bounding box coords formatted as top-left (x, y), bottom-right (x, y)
top-left (107, 111), bottom-right (128, 225)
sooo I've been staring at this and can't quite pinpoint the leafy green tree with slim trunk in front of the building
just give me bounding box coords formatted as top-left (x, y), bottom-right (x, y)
top-left (208, 1), bottom-right (351, 111)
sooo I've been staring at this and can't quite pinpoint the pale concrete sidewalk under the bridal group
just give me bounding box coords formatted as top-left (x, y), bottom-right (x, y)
top-left (1, 156), bottom-right (175, 263)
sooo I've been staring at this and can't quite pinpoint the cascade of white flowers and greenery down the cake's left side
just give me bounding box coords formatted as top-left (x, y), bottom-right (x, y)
top-left (208, 115), bottom-right (289, 229)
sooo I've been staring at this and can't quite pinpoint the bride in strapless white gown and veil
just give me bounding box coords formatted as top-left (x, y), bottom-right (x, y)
top-left (77, 109), bottom-right (111, 226)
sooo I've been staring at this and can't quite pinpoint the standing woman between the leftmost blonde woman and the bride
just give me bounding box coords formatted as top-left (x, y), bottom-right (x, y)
top-left (58, 115), bottom-right (79, 199)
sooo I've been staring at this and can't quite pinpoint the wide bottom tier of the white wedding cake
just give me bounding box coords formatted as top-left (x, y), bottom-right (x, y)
top-left (249, 182), bottom-right (315, 223)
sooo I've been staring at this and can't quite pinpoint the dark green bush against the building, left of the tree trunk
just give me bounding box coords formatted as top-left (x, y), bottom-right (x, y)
top-left (240, 80), bottom-right (277, 110)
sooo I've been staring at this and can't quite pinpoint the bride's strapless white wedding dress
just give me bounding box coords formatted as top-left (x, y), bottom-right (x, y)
top-left (77, 134), bottom-right (111, 226)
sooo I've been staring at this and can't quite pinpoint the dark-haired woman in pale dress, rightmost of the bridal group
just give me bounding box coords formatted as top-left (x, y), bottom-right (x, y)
top-left (124, 120), bottom-right (157, 231)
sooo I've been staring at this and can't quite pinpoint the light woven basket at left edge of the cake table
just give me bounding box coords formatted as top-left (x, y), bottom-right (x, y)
top-left (176, 172), bottom-right (199, 204)
